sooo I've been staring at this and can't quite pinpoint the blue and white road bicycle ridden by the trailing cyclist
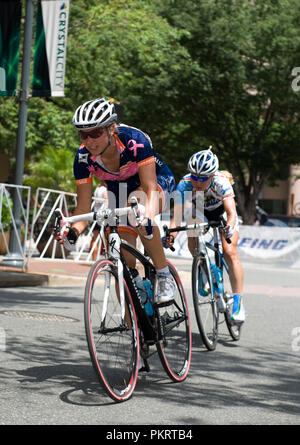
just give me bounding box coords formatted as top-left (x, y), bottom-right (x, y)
top-left (163, 218), bottom-right (241, 351)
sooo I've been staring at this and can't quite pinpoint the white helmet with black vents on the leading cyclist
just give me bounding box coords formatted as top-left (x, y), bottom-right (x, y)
top-left (73, 98), bottom-right (117, 130)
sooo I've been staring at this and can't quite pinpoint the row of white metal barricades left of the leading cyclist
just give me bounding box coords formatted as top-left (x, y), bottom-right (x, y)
top-left (0, 184), bottom-right (166, 268)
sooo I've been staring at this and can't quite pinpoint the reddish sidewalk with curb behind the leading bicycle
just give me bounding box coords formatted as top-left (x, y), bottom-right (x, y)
top-left (0, 257), bottom-right (191, 288)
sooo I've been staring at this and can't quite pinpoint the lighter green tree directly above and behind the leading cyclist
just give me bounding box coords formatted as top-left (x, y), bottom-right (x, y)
top-left (67, 0), bottom-right (193, 172)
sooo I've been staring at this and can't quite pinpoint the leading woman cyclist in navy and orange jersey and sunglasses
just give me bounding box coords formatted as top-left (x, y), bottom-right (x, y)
top-left (56, 98), bottom-right (175, 303)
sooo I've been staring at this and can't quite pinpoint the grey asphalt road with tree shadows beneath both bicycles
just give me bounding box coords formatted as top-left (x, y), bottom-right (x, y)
top-left (0, 262), bottom-right (300, 428)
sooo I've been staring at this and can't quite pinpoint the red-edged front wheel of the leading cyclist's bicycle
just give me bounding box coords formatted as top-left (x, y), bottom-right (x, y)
top-left (84, 260), bottom-right (139, 402)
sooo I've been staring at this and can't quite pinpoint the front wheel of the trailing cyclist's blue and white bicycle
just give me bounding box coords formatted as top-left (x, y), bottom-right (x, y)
top-left (192, 255), bottom-right (219, 351)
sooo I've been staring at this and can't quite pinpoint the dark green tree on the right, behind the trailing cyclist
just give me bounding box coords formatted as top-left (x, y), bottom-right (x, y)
top-left (162, 0), bottom-right (300, 223)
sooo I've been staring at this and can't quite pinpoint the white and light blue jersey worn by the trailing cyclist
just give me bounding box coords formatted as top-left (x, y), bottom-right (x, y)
top-left (175, 171), bottom-right (234, 220)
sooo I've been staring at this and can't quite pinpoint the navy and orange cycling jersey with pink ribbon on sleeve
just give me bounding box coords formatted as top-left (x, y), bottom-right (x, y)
top-left (74, 125), bottom-right (175, 199)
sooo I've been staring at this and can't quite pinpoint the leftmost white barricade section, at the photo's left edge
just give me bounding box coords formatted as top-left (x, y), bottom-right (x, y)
top-left (0, 183), bottom-right (31, 258)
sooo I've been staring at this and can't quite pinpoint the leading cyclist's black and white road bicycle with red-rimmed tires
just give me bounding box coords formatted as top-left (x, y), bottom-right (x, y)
top-left (56, 200), bottom-right (192, 402)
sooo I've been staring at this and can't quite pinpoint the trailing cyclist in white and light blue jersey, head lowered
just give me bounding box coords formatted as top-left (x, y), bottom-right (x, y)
top-left (163, 147), bottom-right (245, 323)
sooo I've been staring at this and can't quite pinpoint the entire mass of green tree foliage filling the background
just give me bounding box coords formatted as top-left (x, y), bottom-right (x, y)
top-left (0, 0), bottom-right (300, 222)
